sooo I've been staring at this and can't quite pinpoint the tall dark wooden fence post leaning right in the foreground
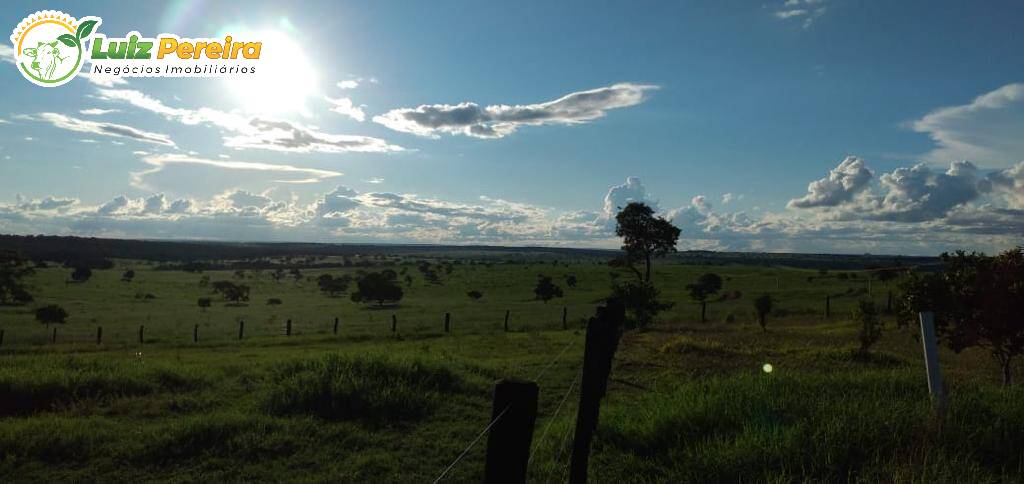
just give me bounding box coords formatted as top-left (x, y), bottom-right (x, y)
top-left (569, 301), bottom-right (626, 483)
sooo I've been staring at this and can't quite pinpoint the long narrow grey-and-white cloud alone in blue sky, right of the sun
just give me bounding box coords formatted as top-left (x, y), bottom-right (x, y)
top-left (374, 83), bottom-right (657, 138)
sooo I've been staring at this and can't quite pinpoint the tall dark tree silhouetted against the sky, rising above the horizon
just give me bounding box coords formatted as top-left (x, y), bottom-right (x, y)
top-left (615, 202), bottom-right (679, 282)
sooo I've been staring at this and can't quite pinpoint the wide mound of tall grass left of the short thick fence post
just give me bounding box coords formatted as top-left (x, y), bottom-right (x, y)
top-left (261, 349), bottom-right (461, 424)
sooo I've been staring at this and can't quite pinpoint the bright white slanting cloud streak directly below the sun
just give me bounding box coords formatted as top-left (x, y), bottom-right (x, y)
top-left (99, 89), bottom-right (402, 153)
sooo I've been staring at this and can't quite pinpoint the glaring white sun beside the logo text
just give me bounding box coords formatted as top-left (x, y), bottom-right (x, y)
top-left (223, 30), bottom-right (318, 115)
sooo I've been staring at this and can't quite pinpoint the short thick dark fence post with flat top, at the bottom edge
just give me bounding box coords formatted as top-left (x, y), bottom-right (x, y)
top-left (483, 380), bottom-right (539, 483)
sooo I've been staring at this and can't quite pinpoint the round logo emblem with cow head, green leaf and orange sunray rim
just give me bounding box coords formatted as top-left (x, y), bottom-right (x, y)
top-left (10, 10), bottom-right (99, 87)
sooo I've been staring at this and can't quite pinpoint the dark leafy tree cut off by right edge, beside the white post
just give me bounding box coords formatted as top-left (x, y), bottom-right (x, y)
top-left (898, 247), bottom-right (1024, 385)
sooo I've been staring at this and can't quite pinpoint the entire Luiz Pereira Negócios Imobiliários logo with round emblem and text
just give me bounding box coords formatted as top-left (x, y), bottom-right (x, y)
top-left (10, 10), bottom-right (263, 87)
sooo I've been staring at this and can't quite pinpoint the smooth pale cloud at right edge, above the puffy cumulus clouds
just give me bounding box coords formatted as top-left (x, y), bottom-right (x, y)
top-left (911, 83), bottom-right (1024, 168)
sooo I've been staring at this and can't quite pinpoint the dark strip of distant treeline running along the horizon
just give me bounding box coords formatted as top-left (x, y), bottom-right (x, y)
top-left (0, 235), bottom-right (940, 271)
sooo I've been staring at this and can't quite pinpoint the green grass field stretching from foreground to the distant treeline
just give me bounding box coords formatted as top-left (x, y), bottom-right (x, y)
top-left (0, 256), bottom-right (1024, 482)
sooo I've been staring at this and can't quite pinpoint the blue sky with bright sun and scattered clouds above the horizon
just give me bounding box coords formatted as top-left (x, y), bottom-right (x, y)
top-left (0, 0), bottom-right (1024, 255)
